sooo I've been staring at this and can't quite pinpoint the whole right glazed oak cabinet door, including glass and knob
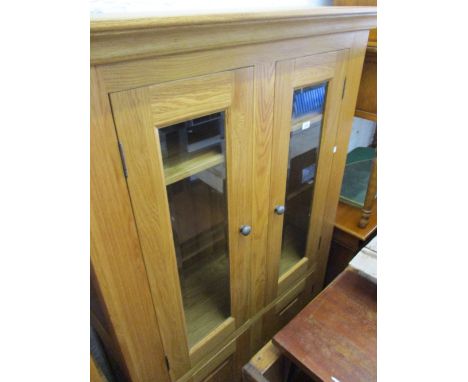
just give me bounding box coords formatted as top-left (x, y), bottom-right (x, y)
top-left (267, 50), bottom-right (348, 301)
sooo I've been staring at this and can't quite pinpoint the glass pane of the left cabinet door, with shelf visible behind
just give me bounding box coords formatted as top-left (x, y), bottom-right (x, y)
top-left (158, 113), bottom-right (230, 346)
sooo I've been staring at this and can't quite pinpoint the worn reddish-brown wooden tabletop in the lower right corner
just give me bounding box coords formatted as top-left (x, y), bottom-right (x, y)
top-left (273, 268), bottom-right (377, 382)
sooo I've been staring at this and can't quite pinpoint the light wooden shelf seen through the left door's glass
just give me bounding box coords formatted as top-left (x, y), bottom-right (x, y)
top-left (164, 149), bottom-right (224, 185)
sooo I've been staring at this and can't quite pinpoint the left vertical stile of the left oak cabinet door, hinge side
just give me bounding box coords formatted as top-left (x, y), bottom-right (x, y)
top-left (111, 87), bottom-right (190, 379)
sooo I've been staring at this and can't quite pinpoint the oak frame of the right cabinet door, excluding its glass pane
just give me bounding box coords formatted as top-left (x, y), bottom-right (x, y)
top-left (266, 49), bottom-right (349, 303)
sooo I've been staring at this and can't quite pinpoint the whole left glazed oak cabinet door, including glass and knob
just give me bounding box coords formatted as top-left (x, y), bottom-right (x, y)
top-left (111, 68), bottom-right (253, 380)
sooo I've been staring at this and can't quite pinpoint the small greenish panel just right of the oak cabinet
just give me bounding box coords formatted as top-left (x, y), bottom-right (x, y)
top-left (340, 147), bottom-right (377, 208)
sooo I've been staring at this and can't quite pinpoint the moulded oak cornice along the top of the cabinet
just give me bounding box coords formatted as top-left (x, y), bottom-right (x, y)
top-left (91, 7), bottom-right (377, 65)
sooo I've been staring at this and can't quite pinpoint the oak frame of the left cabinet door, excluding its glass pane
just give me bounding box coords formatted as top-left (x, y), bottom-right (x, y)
top-left (110, 67), bottom-right (253, 380)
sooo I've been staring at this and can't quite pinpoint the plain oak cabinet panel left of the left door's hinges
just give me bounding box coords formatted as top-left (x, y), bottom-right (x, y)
top-left (90, 68), bottom-right (169, 382)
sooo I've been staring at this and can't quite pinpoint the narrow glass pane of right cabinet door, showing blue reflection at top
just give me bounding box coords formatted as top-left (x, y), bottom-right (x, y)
top-left (279, 83), bottom-right (327, 276)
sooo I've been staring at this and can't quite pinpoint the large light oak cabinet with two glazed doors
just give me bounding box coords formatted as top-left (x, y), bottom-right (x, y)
top-left (91, 8), bottom-right (375, 382)
